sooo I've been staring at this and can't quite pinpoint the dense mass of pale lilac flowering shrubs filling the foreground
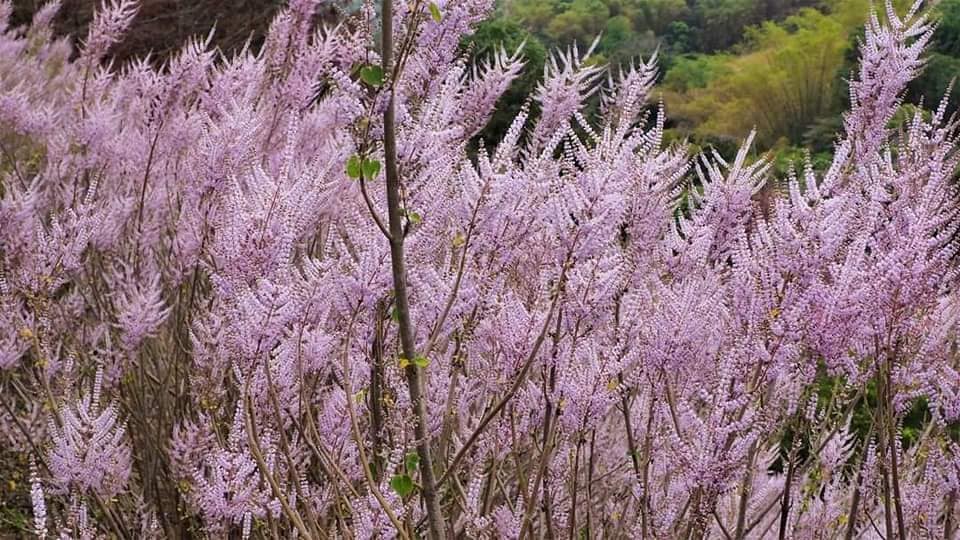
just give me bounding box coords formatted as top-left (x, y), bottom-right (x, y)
top-left (0, 0), bottom-right (960, 539)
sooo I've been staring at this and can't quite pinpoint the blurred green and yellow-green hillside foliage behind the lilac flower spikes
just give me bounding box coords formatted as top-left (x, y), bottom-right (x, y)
top-left (465, 0), bottom-right (960, 173)
